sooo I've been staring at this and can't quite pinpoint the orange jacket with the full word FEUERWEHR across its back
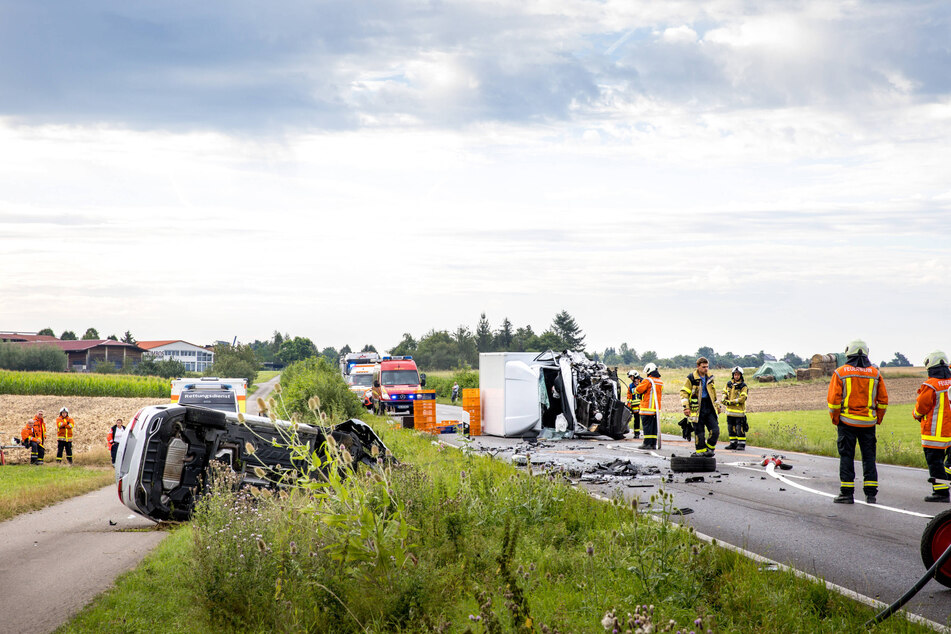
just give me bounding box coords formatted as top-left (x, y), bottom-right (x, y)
top-left (828, 364), bottom-right (888, 427)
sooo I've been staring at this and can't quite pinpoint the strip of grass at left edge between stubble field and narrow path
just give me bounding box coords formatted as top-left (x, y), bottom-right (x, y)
top-left (0, 462), bottom-right (115, 521)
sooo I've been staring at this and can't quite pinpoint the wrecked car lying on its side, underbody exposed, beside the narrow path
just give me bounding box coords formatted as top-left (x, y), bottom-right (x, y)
top-left (116, 405), bottom-right (391, 521)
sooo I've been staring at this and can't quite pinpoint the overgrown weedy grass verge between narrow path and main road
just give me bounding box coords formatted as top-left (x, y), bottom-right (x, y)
top-left (64, 417), bottom-right (927, 634)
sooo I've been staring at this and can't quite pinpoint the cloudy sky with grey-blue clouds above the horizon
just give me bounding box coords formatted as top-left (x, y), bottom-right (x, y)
top-left (0, 0), bottom-right (951, 363)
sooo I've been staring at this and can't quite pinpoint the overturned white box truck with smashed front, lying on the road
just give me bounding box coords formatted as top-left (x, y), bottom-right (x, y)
top-left (479, 350), bottom-right (631, 440)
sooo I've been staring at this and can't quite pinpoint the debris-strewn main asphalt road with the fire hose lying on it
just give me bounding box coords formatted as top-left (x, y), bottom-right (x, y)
top-left (437, 406), bottom-right (951, 625)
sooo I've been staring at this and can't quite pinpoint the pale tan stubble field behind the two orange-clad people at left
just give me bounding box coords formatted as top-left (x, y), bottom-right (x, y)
top-left (0, 394), bottom-right (168, 462)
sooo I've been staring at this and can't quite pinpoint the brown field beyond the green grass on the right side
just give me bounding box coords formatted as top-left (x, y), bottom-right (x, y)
top-left (661, 374), bottom-right (923, 413)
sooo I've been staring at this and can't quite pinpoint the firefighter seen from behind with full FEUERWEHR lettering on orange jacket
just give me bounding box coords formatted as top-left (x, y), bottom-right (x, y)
top-left (828, 339), bottom-right (888, 504)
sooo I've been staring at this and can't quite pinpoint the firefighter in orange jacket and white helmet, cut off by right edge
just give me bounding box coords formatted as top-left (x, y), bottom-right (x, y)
top-left (913, 350), bottom-right (951, 502)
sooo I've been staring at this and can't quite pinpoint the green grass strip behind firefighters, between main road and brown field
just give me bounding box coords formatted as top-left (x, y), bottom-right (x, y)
top-left (661, 404), bottom-right (927, 468)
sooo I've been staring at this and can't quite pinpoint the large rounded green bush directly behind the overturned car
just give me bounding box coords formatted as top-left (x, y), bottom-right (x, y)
top-left (279, 357), bottom-right (366, 422)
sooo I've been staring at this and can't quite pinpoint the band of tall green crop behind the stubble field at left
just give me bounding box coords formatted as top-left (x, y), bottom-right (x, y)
top-left (0, 370), bottom-right (171, 399)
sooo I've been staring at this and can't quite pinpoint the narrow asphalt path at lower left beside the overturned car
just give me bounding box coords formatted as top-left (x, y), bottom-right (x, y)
top-left (0, 482), bottom-right (165, 634)
